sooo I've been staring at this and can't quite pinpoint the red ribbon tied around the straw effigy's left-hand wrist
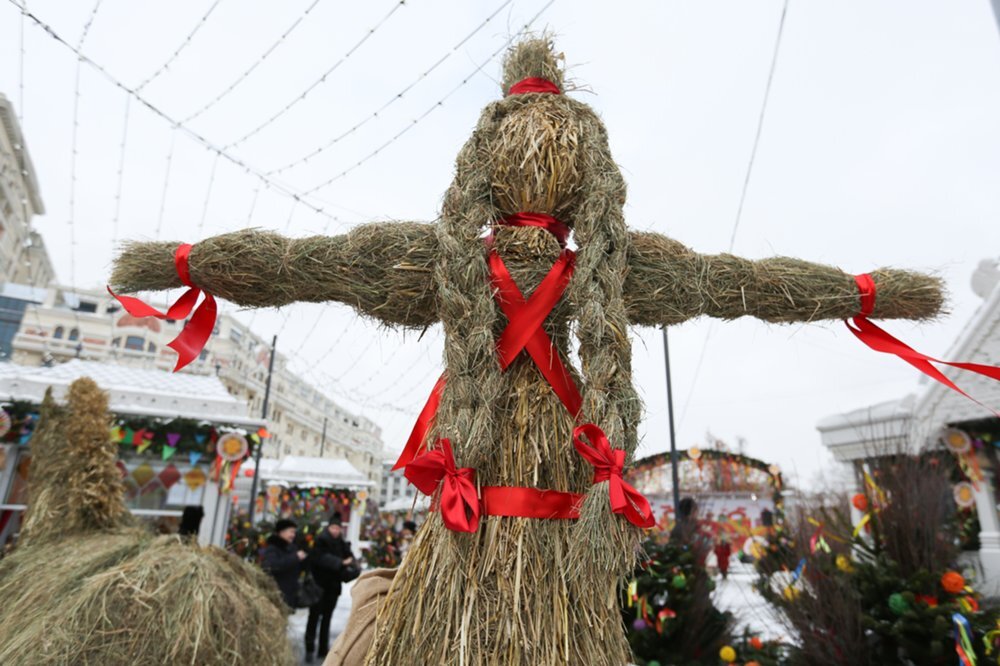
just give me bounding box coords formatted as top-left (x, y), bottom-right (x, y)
top-left (108, 243), bottom-right (219, 372)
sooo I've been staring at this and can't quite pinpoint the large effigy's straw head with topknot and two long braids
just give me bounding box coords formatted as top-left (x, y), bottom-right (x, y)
top-left (435, 37), bottom-right (640, 573)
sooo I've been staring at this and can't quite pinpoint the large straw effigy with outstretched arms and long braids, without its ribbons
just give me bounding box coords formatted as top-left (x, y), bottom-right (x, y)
top-left (112, 38), bottom-right (942, 666)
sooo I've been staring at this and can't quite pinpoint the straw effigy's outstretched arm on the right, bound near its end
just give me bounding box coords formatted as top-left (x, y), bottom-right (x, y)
top-left (623, 232), bottom-right (944, 326)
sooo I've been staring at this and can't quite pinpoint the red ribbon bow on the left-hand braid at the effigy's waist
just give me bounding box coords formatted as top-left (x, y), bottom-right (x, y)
top-left (403, 439), bottom-right (479, 532)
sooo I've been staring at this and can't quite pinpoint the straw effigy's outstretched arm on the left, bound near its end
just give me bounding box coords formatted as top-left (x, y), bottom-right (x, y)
top-left (111, 222), bottom-right (437, 328)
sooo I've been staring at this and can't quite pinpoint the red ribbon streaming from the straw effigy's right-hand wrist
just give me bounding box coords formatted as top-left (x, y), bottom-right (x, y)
top-left (844, 273), bottom-right (1000, 416)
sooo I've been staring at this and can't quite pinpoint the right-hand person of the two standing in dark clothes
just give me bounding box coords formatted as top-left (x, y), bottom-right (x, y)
top-left (306, 513), bottom-right (354, 662)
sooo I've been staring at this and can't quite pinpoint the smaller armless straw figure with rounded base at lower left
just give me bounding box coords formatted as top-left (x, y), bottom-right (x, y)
top-left (0, 379), bottom-right (295, 666)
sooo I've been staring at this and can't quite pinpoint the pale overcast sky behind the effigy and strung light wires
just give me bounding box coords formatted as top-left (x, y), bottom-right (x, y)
top-left (0, 0), bottom-right (1000, 483)
